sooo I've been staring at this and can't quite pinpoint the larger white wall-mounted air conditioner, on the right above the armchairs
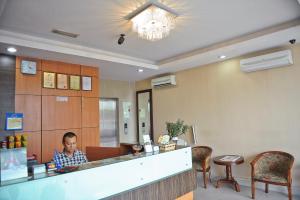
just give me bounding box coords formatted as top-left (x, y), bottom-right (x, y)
top-left (240, 50), bottom-right (293, 72)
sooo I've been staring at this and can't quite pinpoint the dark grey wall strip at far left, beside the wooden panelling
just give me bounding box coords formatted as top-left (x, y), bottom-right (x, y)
top-left (0, 54), bottom-right (16, 141)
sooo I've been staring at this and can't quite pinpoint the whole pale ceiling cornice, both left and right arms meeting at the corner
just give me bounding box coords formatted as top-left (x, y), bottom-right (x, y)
top-left (0, 19), bottom-right (300, 75)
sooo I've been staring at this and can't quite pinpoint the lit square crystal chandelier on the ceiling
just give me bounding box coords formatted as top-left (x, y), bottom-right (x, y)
top-left (131, 4), bottom-right (177, 41)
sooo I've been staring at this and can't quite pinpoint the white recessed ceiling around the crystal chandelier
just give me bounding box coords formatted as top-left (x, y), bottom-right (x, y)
top-left (0, 0), bottom-right (300, 81)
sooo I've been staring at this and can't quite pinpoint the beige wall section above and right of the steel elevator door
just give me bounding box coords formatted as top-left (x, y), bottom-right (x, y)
top-left (100, 80), bottom-right (137, 143)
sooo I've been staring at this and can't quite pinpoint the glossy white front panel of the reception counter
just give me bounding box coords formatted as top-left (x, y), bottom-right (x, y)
top-left (0, 147), bottom-right (192, 200)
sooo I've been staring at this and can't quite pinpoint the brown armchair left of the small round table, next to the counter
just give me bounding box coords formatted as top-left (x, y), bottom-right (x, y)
top-left (192, 146), bottom-right (212, 188)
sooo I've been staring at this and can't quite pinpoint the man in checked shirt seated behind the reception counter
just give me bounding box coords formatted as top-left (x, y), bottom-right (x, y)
top-left (53, 132), bottom-right (88, 167)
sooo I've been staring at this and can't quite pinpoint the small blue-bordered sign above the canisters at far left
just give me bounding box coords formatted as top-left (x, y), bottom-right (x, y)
top-left (5, 113), bottom-right (23, 131)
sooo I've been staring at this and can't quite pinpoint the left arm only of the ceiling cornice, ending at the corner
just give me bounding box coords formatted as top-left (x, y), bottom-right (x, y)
top-left (0, 29), bottom-right (158, 69)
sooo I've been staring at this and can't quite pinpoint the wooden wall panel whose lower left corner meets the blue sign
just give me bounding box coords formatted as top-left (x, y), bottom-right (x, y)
top-left (15, 95), bottom-right (42, 131)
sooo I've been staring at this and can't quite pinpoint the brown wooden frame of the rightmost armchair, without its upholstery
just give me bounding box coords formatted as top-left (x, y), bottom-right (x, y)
top-left (250, 151), bottom-right (294, 200)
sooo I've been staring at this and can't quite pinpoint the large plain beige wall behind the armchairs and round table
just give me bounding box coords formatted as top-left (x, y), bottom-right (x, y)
top-left (136, 45), bottom-right (300, 186)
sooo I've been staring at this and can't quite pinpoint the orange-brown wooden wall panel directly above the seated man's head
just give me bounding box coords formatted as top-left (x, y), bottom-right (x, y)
top-left (42, 96), bottom-right (81, 130)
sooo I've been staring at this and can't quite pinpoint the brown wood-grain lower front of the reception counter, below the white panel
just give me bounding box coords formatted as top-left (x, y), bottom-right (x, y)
top-left (106, 170), bottom-right (197, 200)
